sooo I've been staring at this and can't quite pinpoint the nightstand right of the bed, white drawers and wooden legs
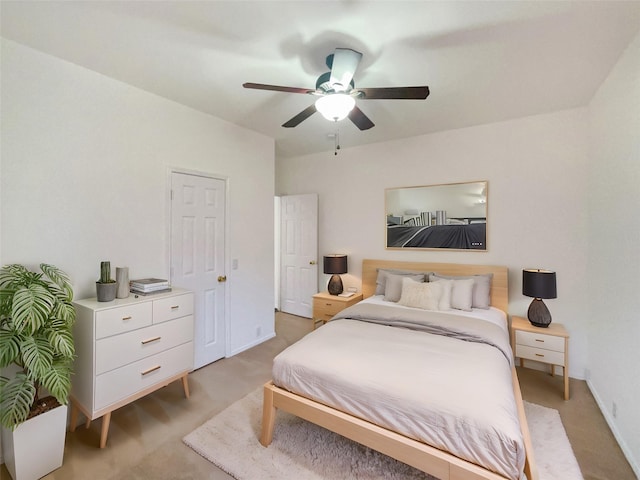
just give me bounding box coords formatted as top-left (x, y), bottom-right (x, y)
top-left (511, 317), bottom-right (569, 400)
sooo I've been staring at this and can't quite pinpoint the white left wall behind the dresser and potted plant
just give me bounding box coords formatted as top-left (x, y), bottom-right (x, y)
top-left (0, 40), bottom-right (275, 354)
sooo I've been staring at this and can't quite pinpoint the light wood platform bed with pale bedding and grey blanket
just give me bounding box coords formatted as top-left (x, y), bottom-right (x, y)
top-left (260, 260), bottom-right (538, 480)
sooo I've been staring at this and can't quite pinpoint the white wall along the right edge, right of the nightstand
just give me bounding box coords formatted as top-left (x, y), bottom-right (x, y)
top-left (587, 31), bottom-right (640, 477)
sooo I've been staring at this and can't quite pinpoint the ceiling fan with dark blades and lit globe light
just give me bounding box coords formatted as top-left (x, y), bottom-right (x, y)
top-left (242, 48), bottom-right (429, 130)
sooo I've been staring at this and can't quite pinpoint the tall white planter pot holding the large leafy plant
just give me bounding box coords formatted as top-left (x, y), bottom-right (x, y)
top-left (2, 405), bottom-right (67, 480)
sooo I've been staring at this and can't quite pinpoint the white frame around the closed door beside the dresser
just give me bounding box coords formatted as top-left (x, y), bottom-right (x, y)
top-left (165, 166), bottom-right (231, 358)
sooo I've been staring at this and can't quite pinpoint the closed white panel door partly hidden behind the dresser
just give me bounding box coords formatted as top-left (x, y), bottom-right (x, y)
top-left (171, 172), bottom-right (226, 368)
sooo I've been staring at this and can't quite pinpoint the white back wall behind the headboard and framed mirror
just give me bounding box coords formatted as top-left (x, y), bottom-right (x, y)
top-left (276, 109), bottom-right (587, 378)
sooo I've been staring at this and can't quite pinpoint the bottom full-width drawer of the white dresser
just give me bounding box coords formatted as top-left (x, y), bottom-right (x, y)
top-left (93, 342), bottom-right (193, 411)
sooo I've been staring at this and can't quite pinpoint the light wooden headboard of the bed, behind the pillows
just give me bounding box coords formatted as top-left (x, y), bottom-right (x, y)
top-left (362, 259), bottom-right (509, 313)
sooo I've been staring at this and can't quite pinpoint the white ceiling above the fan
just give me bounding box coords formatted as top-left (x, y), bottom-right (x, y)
top-left (0, 0), bottom-right (640, 156)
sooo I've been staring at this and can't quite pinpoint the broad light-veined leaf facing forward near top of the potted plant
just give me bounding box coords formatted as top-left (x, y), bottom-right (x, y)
top-left (11, 284), bottom-right (55, 334)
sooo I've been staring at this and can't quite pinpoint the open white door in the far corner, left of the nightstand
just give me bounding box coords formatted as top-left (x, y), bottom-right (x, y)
top-left (280, 194), bottom-right (318, 318)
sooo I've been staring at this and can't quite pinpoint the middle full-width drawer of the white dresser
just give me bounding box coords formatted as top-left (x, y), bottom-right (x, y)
top-left (96, 315), bottom-right (193, 375)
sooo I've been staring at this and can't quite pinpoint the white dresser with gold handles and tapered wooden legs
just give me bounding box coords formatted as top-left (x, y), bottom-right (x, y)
top-left (71, 288), bottom-right (193, 448)
